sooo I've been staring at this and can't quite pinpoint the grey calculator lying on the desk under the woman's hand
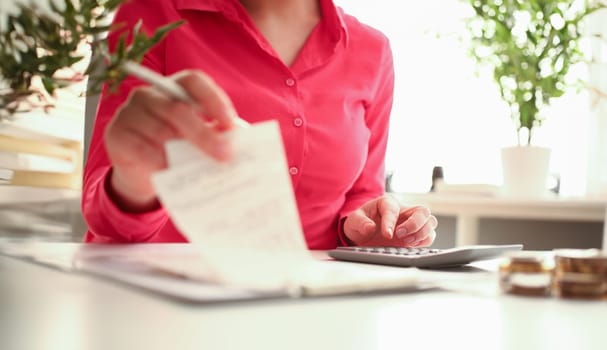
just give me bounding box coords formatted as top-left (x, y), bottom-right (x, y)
top-left (328, 244), bottom-right (523, 268)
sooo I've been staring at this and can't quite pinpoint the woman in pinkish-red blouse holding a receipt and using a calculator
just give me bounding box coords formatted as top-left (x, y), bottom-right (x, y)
top-left (82, 0), bottom-right (437, 249)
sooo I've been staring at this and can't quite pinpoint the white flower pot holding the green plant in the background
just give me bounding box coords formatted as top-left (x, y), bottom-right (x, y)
top-left (502, 146), bottom-right (550, 197)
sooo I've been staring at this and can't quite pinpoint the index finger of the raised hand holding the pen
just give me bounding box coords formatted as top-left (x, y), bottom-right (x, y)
top-left (173, 71), bottom-right (237, 131)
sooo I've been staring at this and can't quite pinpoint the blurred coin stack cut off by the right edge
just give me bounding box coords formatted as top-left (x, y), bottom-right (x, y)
top-left (553, 249), bottom-right (607, 299)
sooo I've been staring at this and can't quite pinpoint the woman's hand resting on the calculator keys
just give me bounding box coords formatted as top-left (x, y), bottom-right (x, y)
top-left (343, 195), bottom-right (438, 247)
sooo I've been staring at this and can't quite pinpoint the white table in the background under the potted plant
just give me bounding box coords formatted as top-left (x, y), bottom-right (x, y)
top-left (396, 193), bottom-right (607, 249)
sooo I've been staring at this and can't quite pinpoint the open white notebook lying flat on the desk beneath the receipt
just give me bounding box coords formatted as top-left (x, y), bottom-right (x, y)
top-left (0, 242), bottom-right (420, 303)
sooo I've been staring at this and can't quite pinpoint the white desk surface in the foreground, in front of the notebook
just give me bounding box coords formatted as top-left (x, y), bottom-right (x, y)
top-left (0, 255), bottom-right (607, 350)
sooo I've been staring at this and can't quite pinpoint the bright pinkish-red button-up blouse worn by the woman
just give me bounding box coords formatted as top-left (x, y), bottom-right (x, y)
top-left (82, 0), bottom-right (394, 249)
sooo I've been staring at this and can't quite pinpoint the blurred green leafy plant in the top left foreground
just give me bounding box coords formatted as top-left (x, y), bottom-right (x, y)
top-left (0, 0), bottom-right (181, 121)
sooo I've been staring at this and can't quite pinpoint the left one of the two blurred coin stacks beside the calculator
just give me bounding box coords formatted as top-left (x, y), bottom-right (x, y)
top-left (499, 251), bottom-right (554, 296)
